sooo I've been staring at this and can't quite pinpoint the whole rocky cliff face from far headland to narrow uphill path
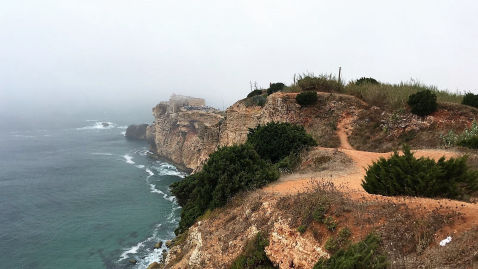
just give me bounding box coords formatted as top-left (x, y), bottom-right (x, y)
top-left (146, 92), bottom-right (364, 171)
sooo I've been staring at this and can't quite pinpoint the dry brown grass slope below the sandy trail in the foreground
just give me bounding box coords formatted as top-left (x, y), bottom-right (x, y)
top-left (277, 180), bottom-right (472, 268)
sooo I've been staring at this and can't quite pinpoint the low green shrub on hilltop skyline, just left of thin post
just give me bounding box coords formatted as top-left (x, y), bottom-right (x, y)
top-left (297, 74), bottom-right (343, 92)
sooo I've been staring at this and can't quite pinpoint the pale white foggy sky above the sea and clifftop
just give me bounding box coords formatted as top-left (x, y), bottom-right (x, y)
top-left (0, 0), bottom-right (478, 117)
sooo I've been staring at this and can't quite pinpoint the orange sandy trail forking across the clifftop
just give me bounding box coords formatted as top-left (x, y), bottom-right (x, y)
top-left (264, 113), bottom-right (478, 233)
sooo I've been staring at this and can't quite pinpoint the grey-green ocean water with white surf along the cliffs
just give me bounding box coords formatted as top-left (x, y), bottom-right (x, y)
top-left (0, 119), bottom-right (184, 268)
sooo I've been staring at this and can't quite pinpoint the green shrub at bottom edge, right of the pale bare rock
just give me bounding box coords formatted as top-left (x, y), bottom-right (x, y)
top-left (314, 231), bottom-right (387, 269)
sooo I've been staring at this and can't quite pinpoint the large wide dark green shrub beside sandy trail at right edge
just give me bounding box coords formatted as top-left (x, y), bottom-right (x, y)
top-left (362, 146), bottom-right (478, 200)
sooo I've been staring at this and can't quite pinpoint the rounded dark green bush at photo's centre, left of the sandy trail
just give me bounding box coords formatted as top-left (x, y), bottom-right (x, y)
top-left (247, 122), bottom-right (317, 163)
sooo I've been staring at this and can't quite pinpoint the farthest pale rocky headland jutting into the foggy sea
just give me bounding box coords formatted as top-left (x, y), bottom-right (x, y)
top-left (146, 96), bottom-right (224, 170)
